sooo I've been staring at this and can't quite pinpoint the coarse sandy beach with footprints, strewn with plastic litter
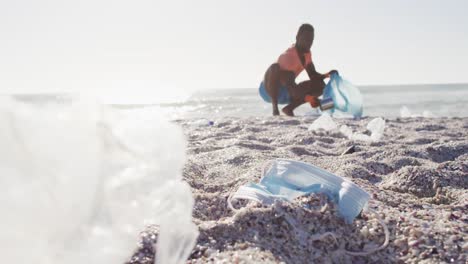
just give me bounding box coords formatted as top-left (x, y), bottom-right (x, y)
top-left (126, 117), bottom-right (468, 263)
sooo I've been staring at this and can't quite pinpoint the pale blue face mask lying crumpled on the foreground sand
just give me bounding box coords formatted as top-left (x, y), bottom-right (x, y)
top-left (231, 159), bottom-right (370, 223)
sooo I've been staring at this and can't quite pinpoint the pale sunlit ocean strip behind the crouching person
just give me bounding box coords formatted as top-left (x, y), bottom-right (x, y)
top-left (159, 84), bottom-right (468, 119)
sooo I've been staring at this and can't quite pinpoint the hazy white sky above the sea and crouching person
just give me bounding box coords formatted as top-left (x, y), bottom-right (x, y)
top-left (0, 0), bottom-right (468, 93)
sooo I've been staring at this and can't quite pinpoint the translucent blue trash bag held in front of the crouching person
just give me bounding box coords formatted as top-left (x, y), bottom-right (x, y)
top-left (323, 73), bottom-right (362, 118)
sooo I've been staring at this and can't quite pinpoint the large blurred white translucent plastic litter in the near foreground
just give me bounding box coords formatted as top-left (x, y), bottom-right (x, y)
top-left (0, 97), bottom-right (197, 264)
